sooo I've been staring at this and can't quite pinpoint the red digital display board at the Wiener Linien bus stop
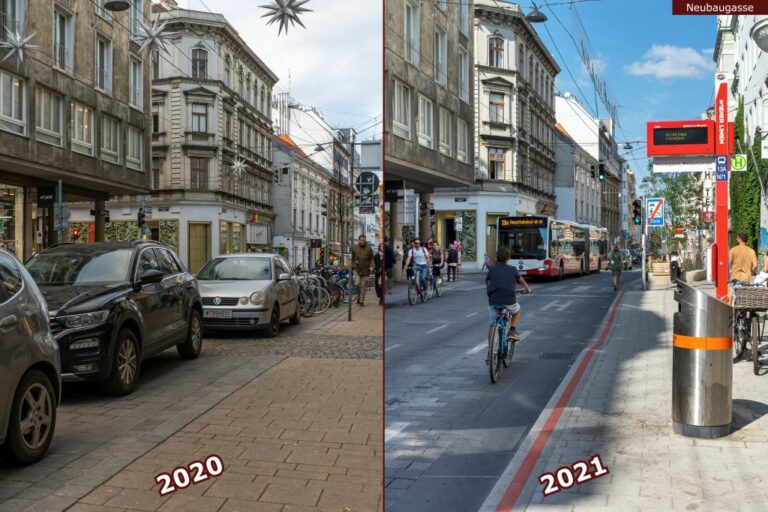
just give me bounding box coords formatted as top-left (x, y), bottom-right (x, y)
top-left (647, 120), bottom-right (715, 156)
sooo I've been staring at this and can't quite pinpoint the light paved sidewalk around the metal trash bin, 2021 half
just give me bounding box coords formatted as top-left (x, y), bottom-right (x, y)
top-left (483, 290), bottom-right (768, 512)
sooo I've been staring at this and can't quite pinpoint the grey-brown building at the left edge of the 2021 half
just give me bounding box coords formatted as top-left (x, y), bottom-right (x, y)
top-left (384, 0), bottom-right (474, 255)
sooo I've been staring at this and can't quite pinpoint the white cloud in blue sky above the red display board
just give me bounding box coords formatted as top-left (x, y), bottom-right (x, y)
top-left (624, 44), bottom-right (715, 79)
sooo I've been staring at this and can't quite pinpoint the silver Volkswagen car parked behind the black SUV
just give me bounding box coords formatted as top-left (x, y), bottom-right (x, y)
top-left (197, 253), bottom-right (301, 337)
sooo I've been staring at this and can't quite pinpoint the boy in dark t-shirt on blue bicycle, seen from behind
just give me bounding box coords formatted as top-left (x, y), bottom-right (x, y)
top-left (485, 247), bottom-right (531, 362)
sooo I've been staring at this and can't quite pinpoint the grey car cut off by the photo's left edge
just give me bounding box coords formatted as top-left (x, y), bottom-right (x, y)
top-left (0, 249), bottom-right (61, 464)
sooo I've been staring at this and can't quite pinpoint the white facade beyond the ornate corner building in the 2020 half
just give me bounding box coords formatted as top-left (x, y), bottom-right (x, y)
top-left (272, 134), bottom-right (331, 268)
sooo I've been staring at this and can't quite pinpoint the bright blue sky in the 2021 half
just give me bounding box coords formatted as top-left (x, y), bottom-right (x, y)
top-left (532, 0), bottom-right (716, 185)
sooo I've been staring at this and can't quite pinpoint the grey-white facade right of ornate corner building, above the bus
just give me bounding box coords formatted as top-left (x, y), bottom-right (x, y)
top-left (555, 124), bottom-right (602, 227)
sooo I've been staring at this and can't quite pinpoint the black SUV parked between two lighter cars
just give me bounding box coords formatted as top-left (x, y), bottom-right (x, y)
top-left (26, 241), bottom-right (203, 395)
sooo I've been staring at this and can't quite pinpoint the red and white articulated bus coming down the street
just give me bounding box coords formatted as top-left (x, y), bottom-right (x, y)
top-left (497, 217), bottom-right (591, 279)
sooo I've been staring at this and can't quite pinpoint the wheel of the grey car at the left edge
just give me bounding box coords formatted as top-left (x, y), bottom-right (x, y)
top-left (2, 370), bottom-right (56, 465)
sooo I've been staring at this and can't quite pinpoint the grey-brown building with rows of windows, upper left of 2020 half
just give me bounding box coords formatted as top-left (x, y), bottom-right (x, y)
top-left (0, 0), bottom-right (151, 258)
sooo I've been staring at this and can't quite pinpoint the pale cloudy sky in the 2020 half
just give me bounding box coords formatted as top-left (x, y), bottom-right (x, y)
top-left (177, 0), bottom-right (383, 140)
